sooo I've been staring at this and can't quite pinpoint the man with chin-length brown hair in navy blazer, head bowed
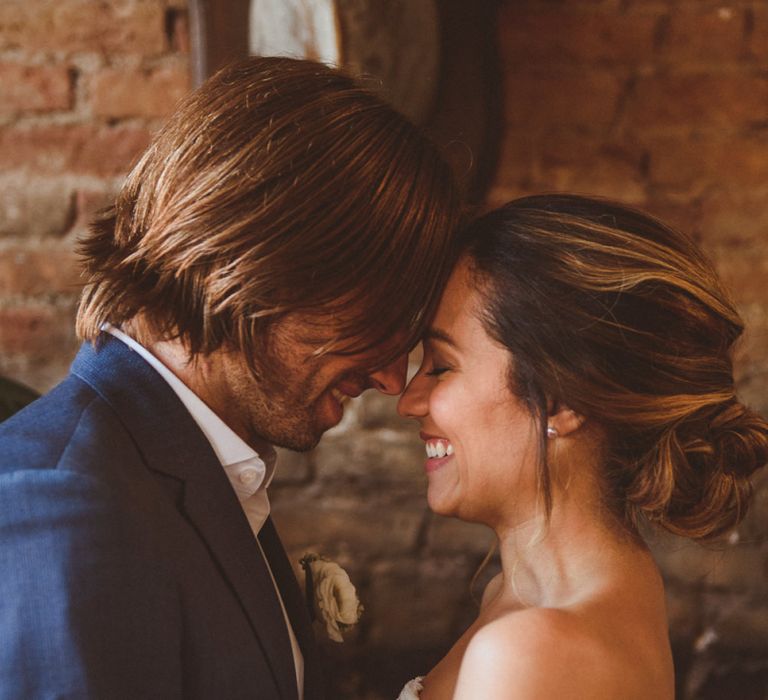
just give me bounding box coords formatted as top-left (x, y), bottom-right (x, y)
top-left (0, 58), bottom-right (457, 700)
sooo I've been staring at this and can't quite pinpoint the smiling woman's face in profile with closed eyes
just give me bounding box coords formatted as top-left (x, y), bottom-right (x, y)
top-left (398, 261), bottom-right (539, 528)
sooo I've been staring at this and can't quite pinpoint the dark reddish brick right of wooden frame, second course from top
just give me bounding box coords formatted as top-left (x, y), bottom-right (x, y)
top-left (504, 68), bottom-right (622, 131)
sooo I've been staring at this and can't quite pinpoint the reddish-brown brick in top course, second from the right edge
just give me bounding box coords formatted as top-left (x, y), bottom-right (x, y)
top-left (660, 3), bottom-right (747, 64)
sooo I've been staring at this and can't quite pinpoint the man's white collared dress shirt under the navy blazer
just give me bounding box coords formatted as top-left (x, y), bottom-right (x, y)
top-left (102, 323), bottom-right (304, 700)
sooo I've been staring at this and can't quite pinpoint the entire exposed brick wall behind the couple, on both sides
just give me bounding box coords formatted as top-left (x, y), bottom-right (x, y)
top-left (0, 0), bottom-right (768, 700)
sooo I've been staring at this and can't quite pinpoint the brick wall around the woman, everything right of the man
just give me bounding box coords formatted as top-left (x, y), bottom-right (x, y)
top-left (308, 0), bottom-right (768, 700)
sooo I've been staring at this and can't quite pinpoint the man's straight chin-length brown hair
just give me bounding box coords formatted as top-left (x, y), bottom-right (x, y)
top-left (78, 57), bottom-right (459, 372)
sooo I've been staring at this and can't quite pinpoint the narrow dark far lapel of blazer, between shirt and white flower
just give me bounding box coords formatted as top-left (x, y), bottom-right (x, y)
top-left (259, 517), bottom-right (325, 700)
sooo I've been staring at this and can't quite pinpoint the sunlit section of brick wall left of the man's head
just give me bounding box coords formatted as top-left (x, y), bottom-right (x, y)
top-left (0, 0), bottom-right (189, 390)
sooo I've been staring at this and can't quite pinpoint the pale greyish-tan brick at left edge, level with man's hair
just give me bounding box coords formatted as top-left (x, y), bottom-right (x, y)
top-left (0, 172), bottom-right (72, 238)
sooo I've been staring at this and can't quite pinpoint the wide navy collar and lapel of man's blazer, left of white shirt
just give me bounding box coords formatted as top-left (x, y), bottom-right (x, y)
top-left (72, 334), bottom-right (298, 700)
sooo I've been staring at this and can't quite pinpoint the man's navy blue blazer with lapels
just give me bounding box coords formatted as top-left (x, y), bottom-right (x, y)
top-left (0, 335), bottom-right (323, 700)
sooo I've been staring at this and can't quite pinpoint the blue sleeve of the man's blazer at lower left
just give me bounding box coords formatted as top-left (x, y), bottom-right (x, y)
top-left (0, 469), bottom-right (183, 700)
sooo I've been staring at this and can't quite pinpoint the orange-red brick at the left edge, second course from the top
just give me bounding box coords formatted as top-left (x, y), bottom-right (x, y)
top-left (0, 63), bottom-right (72, 114)
